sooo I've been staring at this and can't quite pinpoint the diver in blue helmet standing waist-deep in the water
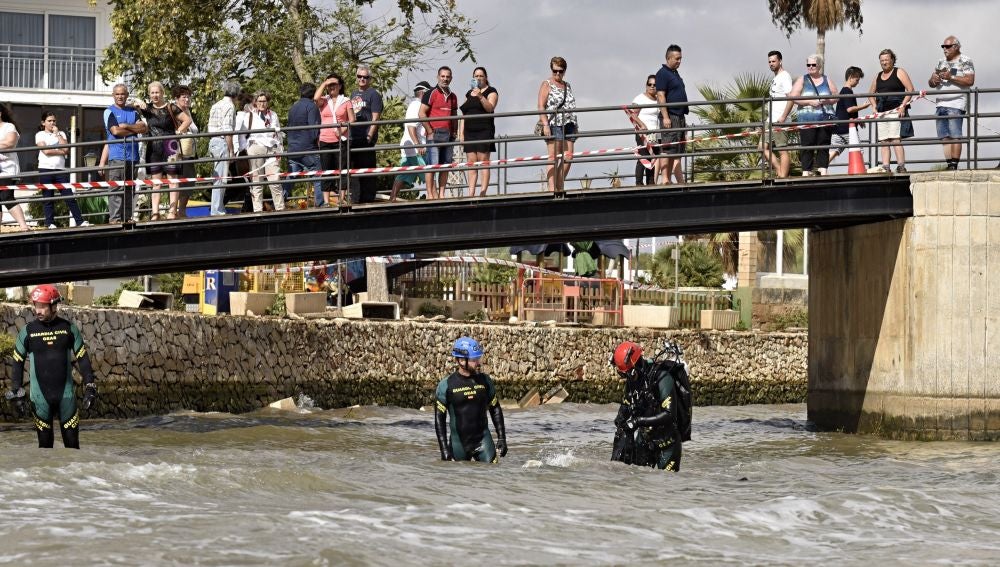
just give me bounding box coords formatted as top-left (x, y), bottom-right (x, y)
top-left (434, 337), bottom-right (507, 463)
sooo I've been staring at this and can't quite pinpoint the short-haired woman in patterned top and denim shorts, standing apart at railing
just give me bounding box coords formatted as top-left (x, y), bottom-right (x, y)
top-left (538, 57), bottom-right (577, 191)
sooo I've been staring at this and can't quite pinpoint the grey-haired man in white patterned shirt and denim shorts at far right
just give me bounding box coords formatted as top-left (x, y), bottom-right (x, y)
top-left (927, 35), bottom-right (976, 170)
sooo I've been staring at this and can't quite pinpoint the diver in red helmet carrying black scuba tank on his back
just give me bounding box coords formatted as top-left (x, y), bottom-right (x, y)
top-left (610, 341), bottom-right (691, 472)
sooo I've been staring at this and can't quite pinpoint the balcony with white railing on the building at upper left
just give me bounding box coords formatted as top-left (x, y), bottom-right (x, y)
top-left (0, 44), bottom-right (104, 91)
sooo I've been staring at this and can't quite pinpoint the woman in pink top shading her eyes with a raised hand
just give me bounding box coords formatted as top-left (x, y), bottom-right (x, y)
top-left (313, 73), bottom-right (358, 205)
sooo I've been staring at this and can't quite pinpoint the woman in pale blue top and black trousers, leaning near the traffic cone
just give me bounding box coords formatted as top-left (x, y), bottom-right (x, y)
top-left (781, 53), bottom-right (837, 177)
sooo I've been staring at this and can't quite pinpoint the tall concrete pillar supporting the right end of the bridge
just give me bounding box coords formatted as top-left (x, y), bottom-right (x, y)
top-left (808, 172), bottom-right (1000, 440)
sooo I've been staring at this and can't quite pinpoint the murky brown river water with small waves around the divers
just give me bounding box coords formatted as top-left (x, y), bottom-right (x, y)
top-left (0, 404), bottom-right (1000, 565)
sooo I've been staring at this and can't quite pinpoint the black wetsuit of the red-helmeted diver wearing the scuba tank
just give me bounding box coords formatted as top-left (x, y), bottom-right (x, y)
top-left (611, 360), bottom-right (681, 471)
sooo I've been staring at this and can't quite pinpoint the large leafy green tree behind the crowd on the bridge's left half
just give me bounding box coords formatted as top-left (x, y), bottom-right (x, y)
top-left (101, 0), bottom-right (475, 115)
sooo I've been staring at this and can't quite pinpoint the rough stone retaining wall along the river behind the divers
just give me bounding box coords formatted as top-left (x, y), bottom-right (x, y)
top-left (0, 304), bottom-right (807, 417)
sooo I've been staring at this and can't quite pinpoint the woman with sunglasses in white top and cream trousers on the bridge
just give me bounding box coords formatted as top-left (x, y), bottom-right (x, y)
top-left (247, 91), bottom-right (285, 213)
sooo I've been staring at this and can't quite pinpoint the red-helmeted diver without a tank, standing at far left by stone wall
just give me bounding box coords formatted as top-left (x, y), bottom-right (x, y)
top-left (4, 285), bottom-right (97, 449)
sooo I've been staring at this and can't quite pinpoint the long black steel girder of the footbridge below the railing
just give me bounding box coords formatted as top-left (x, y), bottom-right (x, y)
top-left (0, 175), bottom-right (913, 287)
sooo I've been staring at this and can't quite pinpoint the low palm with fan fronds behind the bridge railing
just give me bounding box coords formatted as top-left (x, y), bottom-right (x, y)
top-left (693, 73), bottom-right (771, 181)
